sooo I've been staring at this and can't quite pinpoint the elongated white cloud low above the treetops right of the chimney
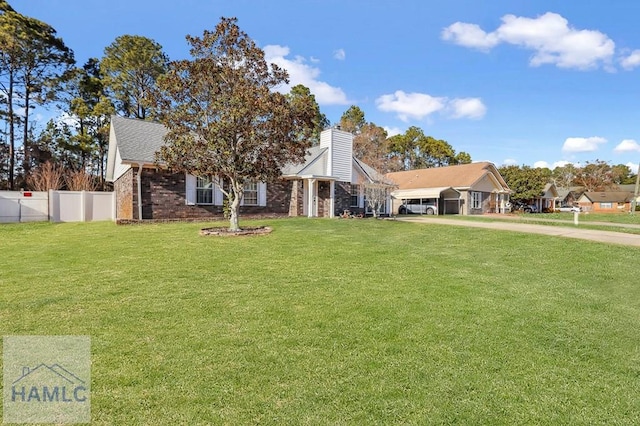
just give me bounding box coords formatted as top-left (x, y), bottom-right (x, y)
top-left (376, 90), bottom-right (487, 122)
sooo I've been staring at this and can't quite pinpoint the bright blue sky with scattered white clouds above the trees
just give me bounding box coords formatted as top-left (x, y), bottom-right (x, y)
top-left (10, 0), bottom-right (640, 171)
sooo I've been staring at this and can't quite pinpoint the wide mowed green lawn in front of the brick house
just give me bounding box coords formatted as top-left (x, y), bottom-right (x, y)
top-left (0, 218), bottom-right (640, 425)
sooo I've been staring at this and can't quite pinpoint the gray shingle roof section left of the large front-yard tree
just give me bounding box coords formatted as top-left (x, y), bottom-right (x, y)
top-left (111, 116), bottom-right (167, 163)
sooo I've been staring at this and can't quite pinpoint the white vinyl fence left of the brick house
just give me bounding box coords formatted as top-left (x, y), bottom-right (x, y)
top-left (0, 190), bottom-right (116, 223)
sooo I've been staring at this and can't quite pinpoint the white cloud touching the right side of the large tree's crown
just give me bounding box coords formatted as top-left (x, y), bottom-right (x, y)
top-left (263, 45), bottom-right (350, 105)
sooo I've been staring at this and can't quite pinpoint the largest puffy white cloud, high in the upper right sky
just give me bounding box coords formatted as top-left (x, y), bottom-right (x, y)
top-left (441, 12), bottom-right (615, 70)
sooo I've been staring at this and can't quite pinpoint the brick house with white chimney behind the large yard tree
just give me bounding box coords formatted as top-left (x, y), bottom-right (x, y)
top-left (107, 116), bottom-right (388, 220)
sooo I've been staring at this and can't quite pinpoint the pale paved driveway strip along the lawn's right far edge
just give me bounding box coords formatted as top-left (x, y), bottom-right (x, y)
top-left (398, 217), bottom-right (640, 247)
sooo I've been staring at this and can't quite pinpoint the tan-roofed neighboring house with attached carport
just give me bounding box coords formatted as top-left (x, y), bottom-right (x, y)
top-left (387, 162), bottom-right (511, 215)
